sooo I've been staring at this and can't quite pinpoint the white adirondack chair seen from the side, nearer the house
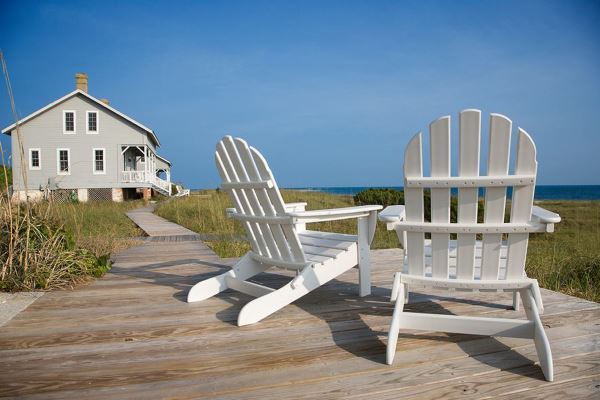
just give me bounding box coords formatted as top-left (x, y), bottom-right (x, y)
top-left (188, 136), bottom-right (382, 326)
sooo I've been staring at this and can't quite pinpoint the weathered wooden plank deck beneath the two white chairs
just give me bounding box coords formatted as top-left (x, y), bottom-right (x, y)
top-left (0, 211), bottom-right (600, 399)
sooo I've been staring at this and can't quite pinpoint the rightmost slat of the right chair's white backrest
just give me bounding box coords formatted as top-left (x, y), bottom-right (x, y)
top-left (506, 128), bottom-right (537, 279)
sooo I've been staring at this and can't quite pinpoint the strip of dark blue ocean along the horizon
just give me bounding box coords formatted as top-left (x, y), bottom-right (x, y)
top-left (289, 185), bottom-right (600, 200)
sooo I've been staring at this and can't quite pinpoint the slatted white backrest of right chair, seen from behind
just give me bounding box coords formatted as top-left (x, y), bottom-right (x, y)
top-left (404, 110), bottom-right (538, 280)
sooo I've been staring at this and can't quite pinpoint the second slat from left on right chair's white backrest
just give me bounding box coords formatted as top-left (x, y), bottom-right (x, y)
top-left (429, 116), bottom-right (450, 279)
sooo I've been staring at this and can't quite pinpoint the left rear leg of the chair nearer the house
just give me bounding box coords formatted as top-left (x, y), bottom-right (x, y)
top-left (187, 254), bottom-right (269, 303)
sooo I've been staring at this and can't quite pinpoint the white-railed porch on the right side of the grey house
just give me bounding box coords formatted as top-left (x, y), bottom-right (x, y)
top-left (119, 145), bottom-right (171, 196)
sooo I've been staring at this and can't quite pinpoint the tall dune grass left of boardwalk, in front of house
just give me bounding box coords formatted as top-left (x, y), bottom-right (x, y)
top-left (0, 198), bottom-right (141, 291)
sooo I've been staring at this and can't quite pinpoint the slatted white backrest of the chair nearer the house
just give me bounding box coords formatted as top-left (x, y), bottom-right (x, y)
top-left (215, 136), bottom-right (306, 268)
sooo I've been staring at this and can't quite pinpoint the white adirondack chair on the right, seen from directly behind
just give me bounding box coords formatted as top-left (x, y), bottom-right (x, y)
top-left (379, 110), bottom-right (560, 381)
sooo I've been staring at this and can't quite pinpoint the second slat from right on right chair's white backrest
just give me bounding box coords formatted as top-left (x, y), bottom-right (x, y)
top-left (481, 114), bottom-right (512, 279)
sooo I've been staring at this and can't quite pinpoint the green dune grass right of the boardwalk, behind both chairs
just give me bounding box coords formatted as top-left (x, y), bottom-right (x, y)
top-left (156, 190), bottom-right (600, 301)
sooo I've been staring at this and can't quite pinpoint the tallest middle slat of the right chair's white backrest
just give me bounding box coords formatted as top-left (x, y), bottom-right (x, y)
top-left (456, 110), bottom-right (481, 279)
